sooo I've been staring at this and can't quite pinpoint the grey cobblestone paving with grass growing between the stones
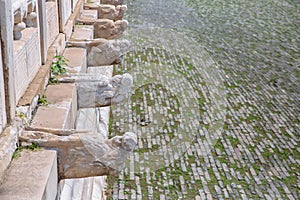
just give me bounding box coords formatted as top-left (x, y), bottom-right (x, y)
top-left (108, 0), bottom-right (300, 200)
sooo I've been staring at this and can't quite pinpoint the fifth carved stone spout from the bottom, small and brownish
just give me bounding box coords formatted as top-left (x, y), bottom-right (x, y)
top-left (84, 4), bottom-right (127, 21)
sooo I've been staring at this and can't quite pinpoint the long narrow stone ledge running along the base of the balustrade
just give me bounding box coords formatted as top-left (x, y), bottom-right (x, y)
top-left (0, 0), bottom-right (85, 194)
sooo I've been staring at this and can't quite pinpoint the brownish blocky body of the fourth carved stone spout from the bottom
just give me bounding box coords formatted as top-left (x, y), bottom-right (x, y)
top-left (94, 19), bottom-right (128, 39)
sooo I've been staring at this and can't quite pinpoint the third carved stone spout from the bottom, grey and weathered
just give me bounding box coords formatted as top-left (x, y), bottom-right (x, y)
top-left (68, 39), bottom-right (129, 67)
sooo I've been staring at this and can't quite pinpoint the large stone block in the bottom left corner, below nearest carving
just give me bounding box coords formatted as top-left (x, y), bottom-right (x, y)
top-left (0, 150), bottom-right (58, 200)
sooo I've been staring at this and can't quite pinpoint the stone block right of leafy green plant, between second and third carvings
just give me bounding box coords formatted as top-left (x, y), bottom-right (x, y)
top-left (63, 48), bottom-right (87, 73)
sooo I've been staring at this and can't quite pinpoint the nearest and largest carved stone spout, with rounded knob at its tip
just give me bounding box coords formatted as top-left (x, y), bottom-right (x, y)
top-left (20, 130), bottom-right (137, 179)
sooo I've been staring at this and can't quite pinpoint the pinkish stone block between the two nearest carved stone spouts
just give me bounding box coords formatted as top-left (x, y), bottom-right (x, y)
top-left (31, 83), bottom-right (77, 129)
